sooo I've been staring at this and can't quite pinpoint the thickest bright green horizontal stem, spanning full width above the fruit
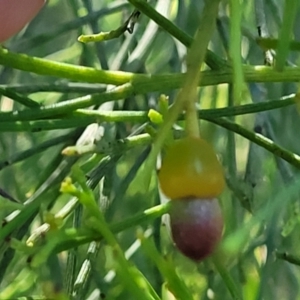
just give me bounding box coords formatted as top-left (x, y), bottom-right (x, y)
top-left (0, 48), bottom-right (300, 89)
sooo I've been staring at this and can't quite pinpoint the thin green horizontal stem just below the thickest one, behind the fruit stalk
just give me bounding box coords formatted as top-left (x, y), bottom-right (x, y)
top-left (0, 94), bottom-right (297, 131)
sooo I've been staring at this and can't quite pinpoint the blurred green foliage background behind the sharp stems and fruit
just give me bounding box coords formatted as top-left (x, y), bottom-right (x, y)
top-left (0, 0), bottom-right (300, 300)
